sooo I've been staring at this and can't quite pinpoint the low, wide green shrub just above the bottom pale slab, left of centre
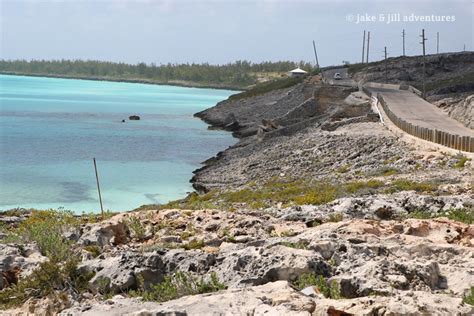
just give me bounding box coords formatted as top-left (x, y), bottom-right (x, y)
top-left (136, 272), bottom-right (226, 302)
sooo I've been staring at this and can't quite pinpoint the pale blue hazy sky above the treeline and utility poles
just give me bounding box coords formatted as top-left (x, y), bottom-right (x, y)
top-left (0, 0), bottom-right (474, 66)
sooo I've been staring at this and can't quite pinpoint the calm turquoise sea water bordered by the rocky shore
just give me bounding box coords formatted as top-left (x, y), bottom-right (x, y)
top-left (0, 75), bottom-right (235, 212)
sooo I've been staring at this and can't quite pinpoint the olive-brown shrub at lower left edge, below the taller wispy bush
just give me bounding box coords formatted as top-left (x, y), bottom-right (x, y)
top-left (0, 257), bottom-right (93, 309)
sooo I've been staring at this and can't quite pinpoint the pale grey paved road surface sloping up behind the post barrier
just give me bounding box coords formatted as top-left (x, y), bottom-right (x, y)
top-left (368, 87), bottom-right (474, 136)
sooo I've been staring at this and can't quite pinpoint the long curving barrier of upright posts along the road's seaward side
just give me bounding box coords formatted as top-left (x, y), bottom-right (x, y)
top-left (376, 94), bottom-right (474, 153)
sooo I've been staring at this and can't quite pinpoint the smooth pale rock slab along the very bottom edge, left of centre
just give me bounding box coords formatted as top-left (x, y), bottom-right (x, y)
top-left (60, 281), bottom-right (316, 316)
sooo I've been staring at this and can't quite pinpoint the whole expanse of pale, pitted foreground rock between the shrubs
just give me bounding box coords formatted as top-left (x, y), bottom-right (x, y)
top-left (1, 193), bottom-right (474, 315)
